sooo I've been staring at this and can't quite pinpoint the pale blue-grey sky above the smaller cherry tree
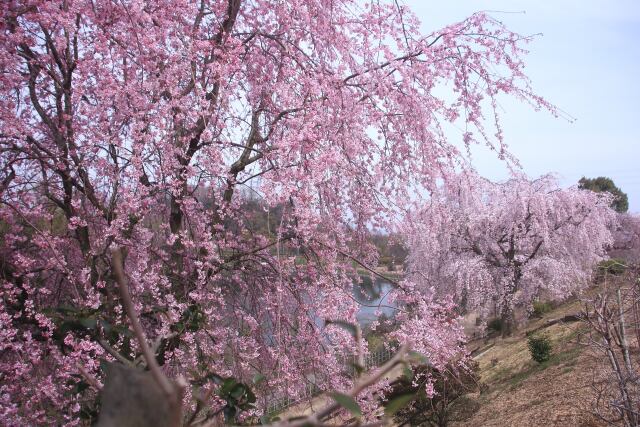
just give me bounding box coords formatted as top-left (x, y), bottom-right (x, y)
top-left (404, 0), bottom-right (640, 212)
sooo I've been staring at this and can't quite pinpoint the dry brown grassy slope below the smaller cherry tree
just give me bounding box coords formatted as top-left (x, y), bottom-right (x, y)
top-left (452, 302), bottom-right (602, 427)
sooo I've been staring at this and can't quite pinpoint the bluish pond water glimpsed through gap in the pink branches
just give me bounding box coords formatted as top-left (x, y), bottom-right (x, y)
top-left (352, 276), bottom-right (397, 328)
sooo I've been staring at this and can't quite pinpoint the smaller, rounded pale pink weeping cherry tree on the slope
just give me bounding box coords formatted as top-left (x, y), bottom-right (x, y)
top-left (404, 174), bottom-right (616, 333)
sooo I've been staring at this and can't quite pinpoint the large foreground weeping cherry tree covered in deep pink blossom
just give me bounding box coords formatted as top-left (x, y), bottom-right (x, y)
top-left (0, 0), bottom-right (555, 425)
